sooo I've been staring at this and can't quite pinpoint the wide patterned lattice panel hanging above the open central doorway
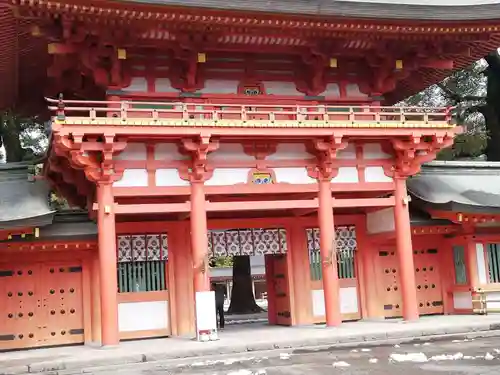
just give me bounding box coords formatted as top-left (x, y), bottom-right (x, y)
top-left (208, 229), bottom-right (288, 257)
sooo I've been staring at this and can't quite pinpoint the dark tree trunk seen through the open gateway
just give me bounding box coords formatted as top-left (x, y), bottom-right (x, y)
top-left (227, 255), bottom-right (264, 314)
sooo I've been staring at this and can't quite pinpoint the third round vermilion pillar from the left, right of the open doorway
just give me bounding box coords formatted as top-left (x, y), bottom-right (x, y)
top-left (318, 179), bottom-right (342, 327)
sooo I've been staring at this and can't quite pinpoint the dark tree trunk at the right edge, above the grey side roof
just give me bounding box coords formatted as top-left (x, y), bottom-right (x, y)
top-left (481, 51), bottom-right (500, 161)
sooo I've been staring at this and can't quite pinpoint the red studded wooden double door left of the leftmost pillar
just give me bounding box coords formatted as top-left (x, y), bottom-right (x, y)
top-left (0, 262), bottom-right (84, 350)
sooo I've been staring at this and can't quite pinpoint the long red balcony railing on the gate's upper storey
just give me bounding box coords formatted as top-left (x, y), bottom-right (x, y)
top-left (47, 99), bottom-right (452, 127)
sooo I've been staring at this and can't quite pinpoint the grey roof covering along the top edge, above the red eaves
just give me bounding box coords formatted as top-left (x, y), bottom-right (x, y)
top-left (125, 0), bottom-right (500, 21)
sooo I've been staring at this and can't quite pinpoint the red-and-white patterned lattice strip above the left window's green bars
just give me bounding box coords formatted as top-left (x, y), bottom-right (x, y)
top-left (117, 234), bottom-right (168, 263)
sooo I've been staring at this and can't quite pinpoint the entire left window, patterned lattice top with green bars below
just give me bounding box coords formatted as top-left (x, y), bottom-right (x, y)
top-left (117, 234), bottom-right (168, 293)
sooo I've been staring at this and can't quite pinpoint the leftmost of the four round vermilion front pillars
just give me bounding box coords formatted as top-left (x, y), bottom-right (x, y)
top-left (97, 182), bottom-right (120, 346)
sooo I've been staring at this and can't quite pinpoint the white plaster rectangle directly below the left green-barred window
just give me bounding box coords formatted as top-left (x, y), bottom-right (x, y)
top-left (118, 301), bottom-right (170, 332)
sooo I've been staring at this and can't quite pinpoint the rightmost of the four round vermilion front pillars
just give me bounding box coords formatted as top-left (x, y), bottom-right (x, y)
top-left (394, 177), bottom-right (419, 321)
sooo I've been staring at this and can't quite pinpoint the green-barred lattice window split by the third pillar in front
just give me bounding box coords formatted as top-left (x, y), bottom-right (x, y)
top-left (306, 225), bottom-right (358, 280)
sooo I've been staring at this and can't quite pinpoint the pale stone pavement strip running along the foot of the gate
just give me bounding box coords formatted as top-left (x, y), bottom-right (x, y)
top-left (0, 315), bottom-right (500, 375)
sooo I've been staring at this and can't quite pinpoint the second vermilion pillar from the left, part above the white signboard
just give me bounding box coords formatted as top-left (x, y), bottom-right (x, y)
top-left (191, 181), bottom-right (210, 292)
